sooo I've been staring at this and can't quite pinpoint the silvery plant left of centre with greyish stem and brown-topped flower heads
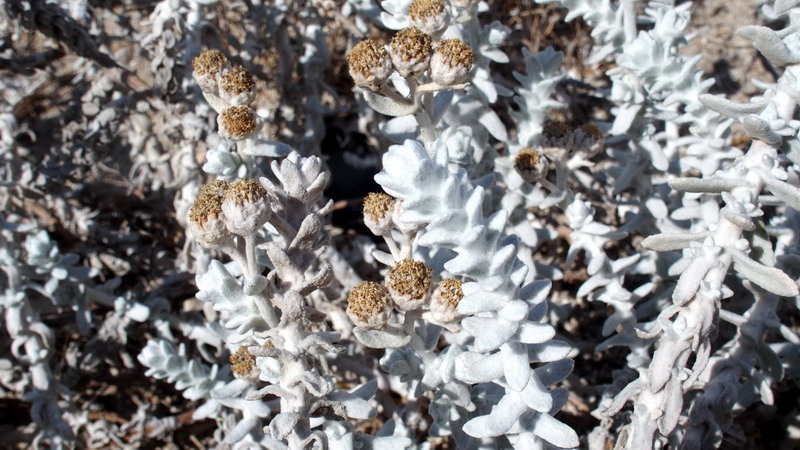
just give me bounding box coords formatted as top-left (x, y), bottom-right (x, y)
top-left (139, 51), bottom-right (394, 449)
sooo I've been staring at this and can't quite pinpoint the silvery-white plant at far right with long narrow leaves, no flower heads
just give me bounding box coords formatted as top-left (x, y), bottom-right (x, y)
top-left (524, 2), bottom-right (798, 448)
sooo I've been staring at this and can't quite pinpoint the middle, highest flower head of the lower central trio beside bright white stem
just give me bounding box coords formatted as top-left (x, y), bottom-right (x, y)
top-left (386, 259), bottom-right (433, 311)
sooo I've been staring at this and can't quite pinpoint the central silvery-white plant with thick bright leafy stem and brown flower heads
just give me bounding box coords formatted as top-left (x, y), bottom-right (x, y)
top-left (348, 1), bottom-right (579, 448)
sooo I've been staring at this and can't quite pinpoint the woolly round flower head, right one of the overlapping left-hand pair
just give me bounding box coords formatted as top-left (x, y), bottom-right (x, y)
top-left (222, 178), bottom-right (272, 236)
